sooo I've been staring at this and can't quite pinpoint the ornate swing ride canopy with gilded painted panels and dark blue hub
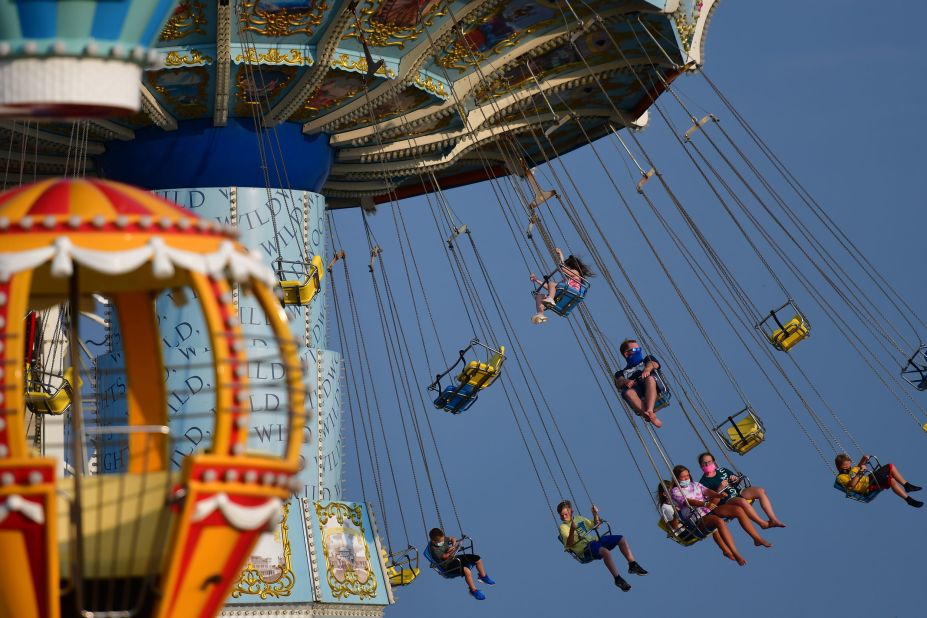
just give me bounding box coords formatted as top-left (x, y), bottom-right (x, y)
top-left (0, 0), bottom-right (715, 207)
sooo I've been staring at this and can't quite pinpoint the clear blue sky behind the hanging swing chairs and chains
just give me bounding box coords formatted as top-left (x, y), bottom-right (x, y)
top-left (330, 0), bottom-right (927, 618)
